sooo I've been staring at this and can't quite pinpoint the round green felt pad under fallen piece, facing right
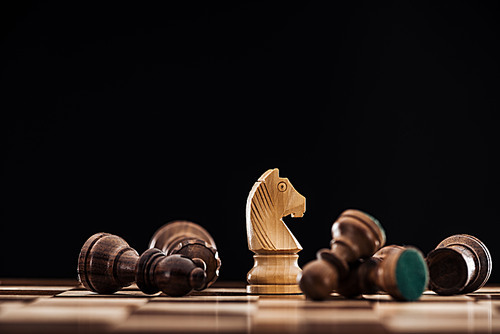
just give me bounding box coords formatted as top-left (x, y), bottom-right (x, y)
top-left (396, 248), bottom-right (429, 301)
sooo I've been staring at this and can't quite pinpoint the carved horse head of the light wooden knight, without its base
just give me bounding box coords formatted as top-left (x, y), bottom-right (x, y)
top-left (246, 168), bottom-right (306, 254)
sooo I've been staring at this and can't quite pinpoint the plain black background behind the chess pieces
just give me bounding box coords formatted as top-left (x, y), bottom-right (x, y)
top-left (0, 1), bottom-right (500, 282)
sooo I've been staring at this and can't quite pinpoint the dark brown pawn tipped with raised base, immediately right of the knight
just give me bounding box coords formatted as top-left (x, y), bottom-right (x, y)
top-left (298, 209), bottom-right (385, 300)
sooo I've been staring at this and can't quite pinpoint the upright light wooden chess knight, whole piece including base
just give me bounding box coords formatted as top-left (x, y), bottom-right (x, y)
top-left (246, 168), bottom-right (306, 294)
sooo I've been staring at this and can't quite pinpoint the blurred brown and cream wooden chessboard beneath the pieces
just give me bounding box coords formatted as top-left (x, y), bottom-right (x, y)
top-left (0, 279), bottom-right (500, 334)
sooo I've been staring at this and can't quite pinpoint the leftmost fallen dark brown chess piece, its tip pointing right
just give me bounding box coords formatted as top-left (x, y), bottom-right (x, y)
top-left (78, 233), bottom-right (205, 297)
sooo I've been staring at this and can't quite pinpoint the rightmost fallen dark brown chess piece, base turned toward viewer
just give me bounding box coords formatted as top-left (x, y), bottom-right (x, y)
top-left (426, 234), bottom-right (492, 295)
